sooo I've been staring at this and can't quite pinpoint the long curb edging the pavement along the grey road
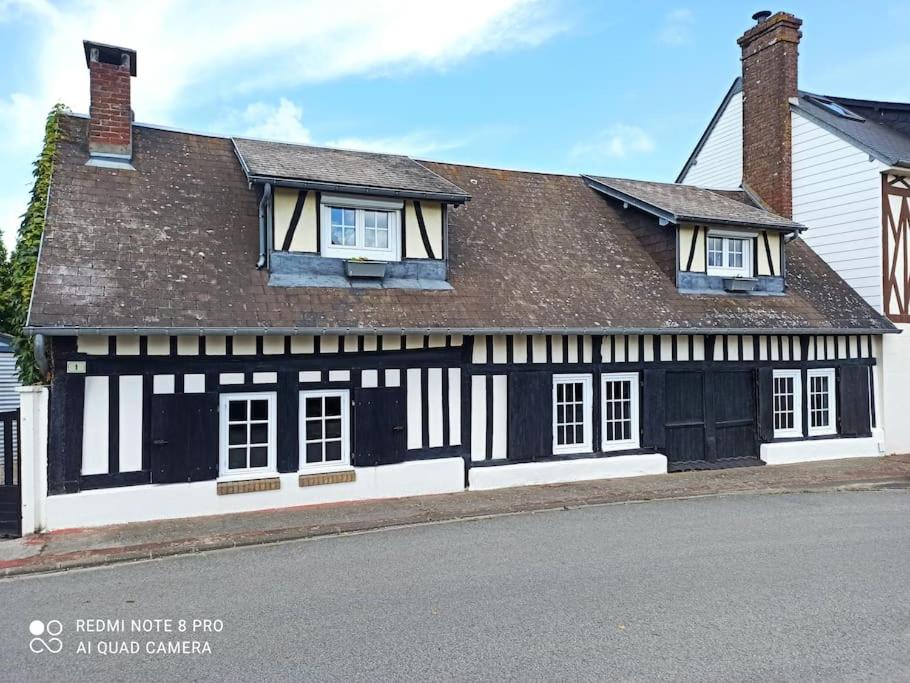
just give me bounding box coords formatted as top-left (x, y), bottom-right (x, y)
top-left (0, 477), bottom-right (910, 579)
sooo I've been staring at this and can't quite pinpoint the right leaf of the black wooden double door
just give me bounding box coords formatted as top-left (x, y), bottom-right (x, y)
top-left (707, 370), bottom-right (758, 464)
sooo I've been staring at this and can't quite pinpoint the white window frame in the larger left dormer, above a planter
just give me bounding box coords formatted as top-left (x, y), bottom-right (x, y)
top-left (319, 195), bottom-right (404, 261)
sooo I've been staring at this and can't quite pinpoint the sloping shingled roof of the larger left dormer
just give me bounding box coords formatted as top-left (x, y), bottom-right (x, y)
top-left (234, 138), bottom-right (470, 202)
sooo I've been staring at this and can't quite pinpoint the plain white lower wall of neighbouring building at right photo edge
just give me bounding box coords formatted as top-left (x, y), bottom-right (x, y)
top-left (879, 323), bottom-right (910, 454)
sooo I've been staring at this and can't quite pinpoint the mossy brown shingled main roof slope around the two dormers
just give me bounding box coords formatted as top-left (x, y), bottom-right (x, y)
top-left (29, 116), bottom-right (894, 334)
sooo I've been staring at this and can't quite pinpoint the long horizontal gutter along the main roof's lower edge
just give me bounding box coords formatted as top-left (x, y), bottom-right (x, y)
top-left (24, 325), bottom-right (901, 337)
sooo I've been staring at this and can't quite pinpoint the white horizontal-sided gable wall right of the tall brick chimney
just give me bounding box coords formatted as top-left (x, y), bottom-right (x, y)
top-left (792, 111), bottom-right (885, 311)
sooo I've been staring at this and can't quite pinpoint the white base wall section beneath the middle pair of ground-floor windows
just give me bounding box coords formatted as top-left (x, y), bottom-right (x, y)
top-left (468, 453), bottom-right (667, 491)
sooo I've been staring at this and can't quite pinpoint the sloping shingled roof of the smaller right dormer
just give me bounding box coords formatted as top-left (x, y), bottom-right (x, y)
top-left (584, 176), bottom-right (803, 231)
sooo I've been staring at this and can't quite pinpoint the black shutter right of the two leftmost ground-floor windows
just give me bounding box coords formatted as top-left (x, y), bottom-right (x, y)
top-left (352, 387), bottom-right (407, 467)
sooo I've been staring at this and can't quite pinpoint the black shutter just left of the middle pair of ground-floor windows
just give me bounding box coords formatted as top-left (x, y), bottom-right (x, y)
top-left (510, 372), bottom-right (553, 460)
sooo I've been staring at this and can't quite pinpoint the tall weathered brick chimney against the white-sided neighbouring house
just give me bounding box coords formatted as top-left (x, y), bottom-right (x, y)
top-left (737, 12), bottom-right (803, 218)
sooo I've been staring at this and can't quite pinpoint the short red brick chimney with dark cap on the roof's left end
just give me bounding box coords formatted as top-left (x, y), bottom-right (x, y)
top-left (82, 40), bottom-right (136, 161)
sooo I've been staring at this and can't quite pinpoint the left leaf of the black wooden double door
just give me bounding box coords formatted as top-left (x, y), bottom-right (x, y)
top-left (664, 371), bottom-right (707, 469)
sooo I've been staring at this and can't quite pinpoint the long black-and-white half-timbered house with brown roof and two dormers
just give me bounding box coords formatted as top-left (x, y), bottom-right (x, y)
top-left (17, 42), bottom-right (895, 529)
